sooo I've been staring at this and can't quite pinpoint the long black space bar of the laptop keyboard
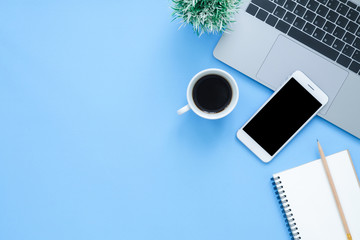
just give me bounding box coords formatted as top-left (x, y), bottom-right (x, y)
top-left (288, 27), bottom-right (340, 61)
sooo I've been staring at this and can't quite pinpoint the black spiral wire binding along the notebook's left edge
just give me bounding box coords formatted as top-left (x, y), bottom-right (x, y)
top-left (271, 176), bottom-right (301, 240)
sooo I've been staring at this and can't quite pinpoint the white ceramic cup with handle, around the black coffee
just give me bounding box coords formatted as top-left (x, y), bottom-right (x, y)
top-left (177, 68), bottom-right (239, 119)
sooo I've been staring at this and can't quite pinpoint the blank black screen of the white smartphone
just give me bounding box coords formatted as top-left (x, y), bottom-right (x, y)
top-left (243, 78), bottom-right (321, 156)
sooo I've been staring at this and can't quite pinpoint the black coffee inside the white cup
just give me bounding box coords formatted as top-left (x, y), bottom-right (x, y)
top-left (192, 74), bottom-right (232, 113)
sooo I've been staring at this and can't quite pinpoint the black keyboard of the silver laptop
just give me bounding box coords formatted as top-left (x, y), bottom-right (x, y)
top-left (246, 0), bottom-right (360, 74)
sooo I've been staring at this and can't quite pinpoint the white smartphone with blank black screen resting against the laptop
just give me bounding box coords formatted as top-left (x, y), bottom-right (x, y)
top-left (237, 71), bottom-right (328, 162)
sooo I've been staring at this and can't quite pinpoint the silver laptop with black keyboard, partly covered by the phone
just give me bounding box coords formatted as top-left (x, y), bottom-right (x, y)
top-left (214, 0), bottom-right (360, 138)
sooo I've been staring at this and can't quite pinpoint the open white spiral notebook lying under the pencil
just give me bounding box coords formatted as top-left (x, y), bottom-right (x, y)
top-left (272, 150), bottom-right (360, 240)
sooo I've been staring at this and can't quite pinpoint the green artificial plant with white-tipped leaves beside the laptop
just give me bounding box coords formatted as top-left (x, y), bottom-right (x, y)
top-left (172, 0), bottom-right (241, 35)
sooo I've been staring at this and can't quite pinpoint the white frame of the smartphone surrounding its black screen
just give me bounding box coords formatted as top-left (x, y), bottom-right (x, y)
top-left (236, 71), bottom-right (328, 163)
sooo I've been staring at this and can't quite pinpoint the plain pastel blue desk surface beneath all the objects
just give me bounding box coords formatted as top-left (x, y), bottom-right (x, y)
top-left (0, 0), bottom-right (360, 240)
